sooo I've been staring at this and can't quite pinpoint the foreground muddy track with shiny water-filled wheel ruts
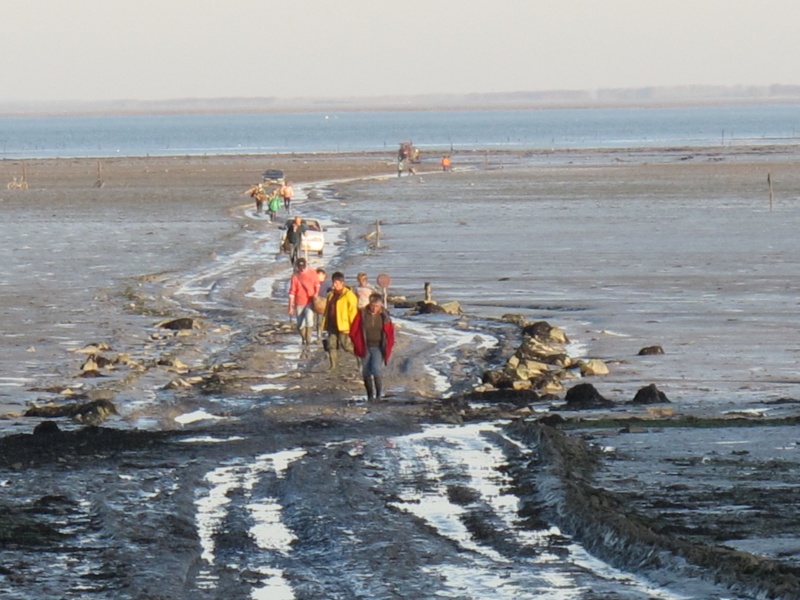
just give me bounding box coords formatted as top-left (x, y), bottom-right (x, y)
top-left (190, 424), bottom-right (692, 600)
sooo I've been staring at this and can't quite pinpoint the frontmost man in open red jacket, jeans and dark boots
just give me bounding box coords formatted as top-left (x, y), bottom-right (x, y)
top-left (350, 293), bottom-right (394, 402)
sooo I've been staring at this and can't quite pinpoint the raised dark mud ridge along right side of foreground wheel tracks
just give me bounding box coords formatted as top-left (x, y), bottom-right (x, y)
top-left (509, 423), bottom-right (800, 600)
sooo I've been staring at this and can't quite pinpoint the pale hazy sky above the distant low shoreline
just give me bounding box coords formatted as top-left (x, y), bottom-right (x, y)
top-left (6, 0), bottom-right (800, 101)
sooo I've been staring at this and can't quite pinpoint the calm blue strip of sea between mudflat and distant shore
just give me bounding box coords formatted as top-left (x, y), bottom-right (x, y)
top-left (0, 105), bottom-right (800, 158)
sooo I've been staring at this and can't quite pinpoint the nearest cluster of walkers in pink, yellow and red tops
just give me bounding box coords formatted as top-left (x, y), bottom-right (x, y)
top-left (289, 268), bottom-right (395, 402)
